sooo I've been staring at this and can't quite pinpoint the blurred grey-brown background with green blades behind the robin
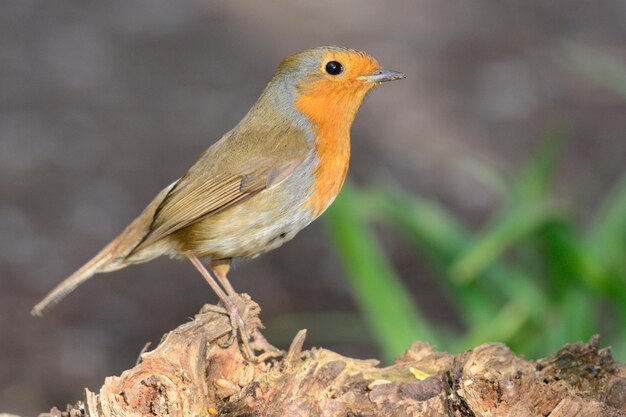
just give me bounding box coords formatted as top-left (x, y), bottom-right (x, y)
top-left (0, 0), bottom-right (626, 415)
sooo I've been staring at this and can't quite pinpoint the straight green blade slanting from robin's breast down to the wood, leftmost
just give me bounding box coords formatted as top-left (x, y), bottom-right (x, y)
top-left (325, 184), bottom-right (438, 360)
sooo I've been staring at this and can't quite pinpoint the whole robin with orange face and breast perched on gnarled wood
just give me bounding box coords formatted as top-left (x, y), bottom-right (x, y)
top-left (31, 46), bottom-right (405, 352)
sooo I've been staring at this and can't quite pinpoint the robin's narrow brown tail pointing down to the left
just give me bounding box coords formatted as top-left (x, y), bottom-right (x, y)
top-left (30, 245), bottom-right (113, 316)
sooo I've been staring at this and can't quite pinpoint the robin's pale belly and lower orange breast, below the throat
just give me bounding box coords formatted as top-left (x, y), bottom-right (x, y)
top-left (177, 134), bottom-right (350, 258)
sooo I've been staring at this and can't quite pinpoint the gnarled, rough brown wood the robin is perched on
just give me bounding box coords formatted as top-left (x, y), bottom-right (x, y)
top-left (26, 295), bottom-right (626, 417)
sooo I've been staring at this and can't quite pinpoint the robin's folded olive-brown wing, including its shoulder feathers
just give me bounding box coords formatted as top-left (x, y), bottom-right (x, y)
top-left (129, 126), bottom-right (311, 257)
